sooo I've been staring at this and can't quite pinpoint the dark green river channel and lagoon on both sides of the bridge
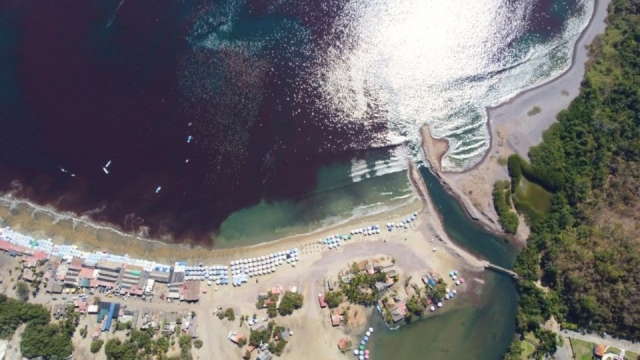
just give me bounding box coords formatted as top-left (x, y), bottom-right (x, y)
top-left (370, 168), bottom-right (517, 360)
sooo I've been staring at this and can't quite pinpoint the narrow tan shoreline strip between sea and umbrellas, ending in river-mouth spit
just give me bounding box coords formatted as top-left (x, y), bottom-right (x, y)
top-left (0, 164), bottom-right (480, 268)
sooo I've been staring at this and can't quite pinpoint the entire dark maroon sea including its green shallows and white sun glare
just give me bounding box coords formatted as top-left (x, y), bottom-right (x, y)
top-left (0, 0), bottom-right (593, 246)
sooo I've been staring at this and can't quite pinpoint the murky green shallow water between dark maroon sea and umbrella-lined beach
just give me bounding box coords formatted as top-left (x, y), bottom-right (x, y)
top-left (214, 152), bottom-right (414, 248)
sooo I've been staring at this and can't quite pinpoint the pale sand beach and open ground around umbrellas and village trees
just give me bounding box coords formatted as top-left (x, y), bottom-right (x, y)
top-left (0, 166), bottom-right (484, 359)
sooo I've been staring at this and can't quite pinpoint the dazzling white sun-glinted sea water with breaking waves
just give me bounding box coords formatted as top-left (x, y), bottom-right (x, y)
top-left (311, 0), bottom-right (593, 172)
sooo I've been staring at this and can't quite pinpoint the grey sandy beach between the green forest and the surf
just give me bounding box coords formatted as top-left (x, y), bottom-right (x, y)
top-left (422, 0), bottom-right (609, 242)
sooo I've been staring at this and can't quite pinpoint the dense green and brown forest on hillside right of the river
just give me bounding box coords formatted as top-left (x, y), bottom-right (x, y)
top-left (505, 0), bottom-right (640, 359)
